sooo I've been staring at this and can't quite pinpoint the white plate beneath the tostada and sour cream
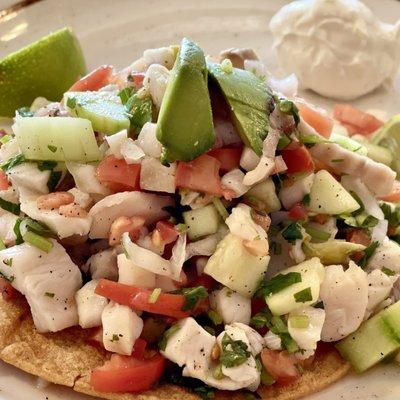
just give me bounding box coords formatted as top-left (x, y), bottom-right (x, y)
top-left (0, 0), bottom-right (400, 400)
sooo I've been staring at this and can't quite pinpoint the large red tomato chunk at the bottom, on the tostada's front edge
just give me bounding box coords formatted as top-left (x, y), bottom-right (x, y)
top-left (90, 353), bottom-right (165, 393)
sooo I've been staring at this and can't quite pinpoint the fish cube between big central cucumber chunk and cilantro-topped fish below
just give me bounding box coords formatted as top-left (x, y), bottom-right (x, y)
top-left (210, 287), bottom-right (251, 324)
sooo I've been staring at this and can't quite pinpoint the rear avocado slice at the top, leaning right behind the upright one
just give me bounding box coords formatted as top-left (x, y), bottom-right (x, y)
top-left (207, 62), bottom-right (272, 155)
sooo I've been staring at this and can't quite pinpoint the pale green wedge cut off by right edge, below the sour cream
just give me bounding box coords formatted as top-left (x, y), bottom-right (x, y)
top-left (371, 114), bottom-right (400, 177)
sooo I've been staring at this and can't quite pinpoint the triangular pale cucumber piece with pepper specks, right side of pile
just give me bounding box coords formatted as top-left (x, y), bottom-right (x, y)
top-left (308, 170), bottom-right (360, 215)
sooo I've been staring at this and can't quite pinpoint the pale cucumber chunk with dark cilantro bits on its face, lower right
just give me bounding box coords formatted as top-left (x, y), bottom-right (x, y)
top-left (265, 257), bottom-right (325, 315)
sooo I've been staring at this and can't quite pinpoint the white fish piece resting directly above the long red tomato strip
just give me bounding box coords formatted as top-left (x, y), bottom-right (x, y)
top-left (118, 254), bottom-right (155, 290)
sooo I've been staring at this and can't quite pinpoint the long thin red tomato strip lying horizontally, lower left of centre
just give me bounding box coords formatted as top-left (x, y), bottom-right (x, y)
top-left (96, 279), bottom-right (189, 319)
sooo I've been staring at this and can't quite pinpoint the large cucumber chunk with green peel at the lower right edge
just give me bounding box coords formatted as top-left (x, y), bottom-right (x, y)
top-left (336, 302), bottom-right (400, 372)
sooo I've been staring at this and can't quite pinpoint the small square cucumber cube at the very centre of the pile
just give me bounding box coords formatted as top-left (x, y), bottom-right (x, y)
top-left (183, 204), bottom-right (221, 240)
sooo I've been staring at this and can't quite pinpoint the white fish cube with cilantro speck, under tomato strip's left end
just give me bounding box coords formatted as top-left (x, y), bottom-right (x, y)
top-left (101, 301), bottom-right (143, 356)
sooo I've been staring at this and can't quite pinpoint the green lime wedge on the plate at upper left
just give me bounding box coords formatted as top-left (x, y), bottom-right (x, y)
top-left (0, 28), bottom-right (86, 117)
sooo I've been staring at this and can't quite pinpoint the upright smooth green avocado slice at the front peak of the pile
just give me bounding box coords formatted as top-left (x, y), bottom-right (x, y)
top-left (156, 38), bottom-right (215, 162)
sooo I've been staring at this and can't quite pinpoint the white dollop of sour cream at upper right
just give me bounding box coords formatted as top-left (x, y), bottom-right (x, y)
top-left (270, 0), bottom-right (400, 100)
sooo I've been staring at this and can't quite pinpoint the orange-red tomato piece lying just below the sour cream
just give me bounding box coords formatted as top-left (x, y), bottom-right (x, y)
top-left (333, 104), bottom-right (383, 135)
